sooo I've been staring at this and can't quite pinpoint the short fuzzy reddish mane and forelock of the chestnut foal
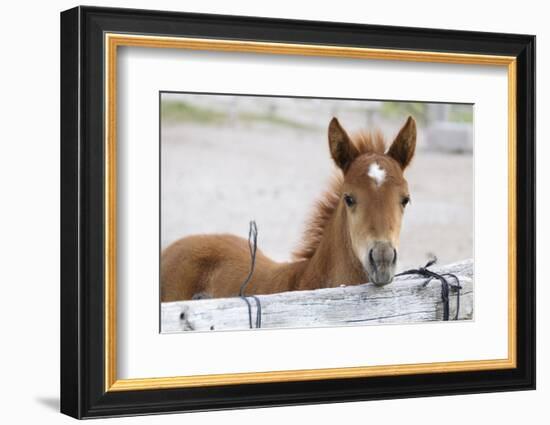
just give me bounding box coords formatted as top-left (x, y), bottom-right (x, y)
top-left (292, 131), bottom-right (386, 261)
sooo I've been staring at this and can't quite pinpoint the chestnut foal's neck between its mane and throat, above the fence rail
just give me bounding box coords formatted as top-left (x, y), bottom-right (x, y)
top-left (297, 202), bottom-right (368, 289)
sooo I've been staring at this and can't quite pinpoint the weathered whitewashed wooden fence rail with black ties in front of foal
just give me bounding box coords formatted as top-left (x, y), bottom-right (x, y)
top-left (161, 260), bottom-right (473, 333)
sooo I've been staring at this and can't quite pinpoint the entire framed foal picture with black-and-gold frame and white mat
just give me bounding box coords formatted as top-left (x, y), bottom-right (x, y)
top-left (61, 7), bottom-right (535, 418)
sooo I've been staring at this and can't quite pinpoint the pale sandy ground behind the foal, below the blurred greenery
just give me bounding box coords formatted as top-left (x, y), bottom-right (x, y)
top-left (161, 123), bottom-right (473, 269)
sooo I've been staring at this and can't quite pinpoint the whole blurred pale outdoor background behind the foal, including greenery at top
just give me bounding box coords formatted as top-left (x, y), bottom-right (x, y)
top-left (161, 93), bottom-right (473, 270)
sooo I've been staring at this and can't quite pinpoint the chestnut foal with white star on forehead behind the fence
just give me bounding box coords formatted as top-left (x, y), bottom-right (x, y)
top-left (161, 117), bottom-right (416, 302)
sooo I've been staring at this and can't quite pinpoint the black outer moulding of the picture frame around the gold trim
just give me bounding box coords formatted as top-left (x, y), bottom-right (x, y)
top-left (61, 7), bottom-right (535, 418)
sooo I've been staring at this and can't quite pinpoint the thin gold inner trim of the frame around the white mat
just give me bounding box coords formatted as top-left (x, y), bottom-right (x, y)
top-left (104, 33), bottom-right (517, 391)
